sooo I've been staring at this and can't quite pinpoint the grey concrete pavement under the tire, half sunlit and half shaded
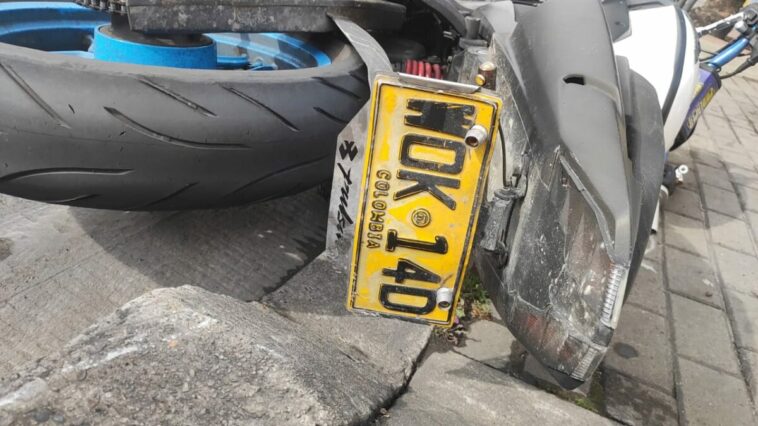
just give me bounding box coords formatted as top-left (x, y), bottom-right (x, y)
top-left (0, 191), bottom-right (332, 377)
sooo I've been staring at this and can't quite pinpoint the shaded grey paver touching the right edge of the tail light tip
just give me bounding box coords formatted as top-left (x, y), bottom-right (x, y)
top-left (605, 305), bottom-right (674, 393)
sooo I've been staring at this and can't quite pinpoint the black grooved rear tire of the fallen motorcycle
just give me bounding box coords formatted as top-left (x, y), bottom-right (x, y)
top-left (0, 34), bottom-right (368, 210)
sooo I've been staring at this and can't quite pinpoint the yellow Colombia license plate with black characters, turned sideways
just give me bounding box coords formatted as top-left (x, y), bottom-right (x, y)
top-left (347, 75), bottom-right (501, 325)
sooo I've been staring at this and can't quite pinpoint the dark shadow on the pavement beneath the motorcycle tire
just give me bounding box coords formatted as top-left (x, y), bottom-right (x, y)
top-left (71, 191), bottom-right (327, 301)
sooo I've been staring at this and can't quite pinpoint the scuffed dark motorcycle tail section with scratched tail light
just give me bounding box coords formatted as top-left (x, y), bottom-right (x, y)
top-left (475, 0), bottom-right (664, 388)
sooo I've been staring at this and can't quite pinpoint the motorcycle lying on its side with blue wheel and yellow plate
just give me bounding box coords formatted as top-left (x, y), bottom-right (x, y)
top-left (0, 0), bottom-right (758, 388)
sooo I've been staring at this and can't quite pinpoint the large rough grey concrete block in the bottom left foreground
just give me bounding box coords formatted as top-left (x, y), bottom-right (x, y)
top-left (0, 286), bottom-right (428, 425)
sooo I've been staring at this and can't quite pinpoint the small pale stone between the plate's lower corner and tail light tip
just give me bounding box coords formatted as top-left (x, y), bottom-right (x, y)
top-left (453, 320), bottom-right (525, 372)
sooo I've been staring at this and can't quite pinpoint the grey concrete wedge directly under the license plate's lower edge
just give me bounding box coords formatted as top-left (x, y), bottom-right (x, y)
top-left (261, 252), bottom-right (432, 379)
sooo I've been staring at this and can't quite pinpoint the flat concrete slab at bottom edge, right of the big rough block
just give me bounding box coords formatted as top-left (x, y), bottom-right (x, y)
top-left (381, 352), bottom-right (613, 426)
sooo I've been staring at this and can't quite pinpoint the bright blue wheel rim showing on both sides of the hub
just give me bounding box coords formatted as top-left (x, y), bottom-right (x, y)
top-left (0, 2), bottom-right (331, 71)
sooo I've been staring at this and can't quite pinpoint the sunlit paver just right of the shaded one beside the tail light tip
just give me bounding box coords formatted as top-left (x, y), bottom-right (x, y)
top-left (671, 294), bottom-right (740, 375)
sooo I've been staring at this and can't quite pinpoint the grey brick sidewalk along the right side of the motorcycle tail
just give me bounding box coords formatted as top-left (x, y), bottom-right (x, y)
top-left (604, 78), bottom-right (758, 425)
